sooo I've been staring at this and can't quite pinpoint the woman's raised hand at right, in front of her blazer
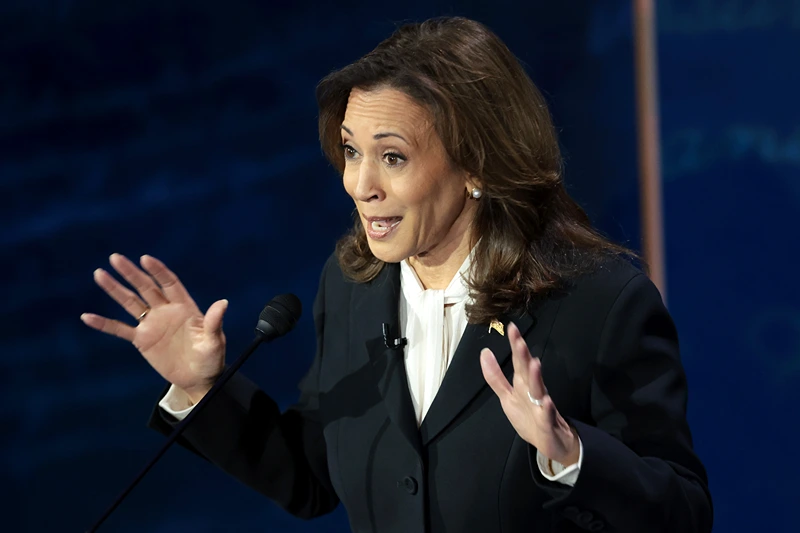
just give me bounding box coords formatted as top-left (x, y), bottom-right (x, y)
top-left (481, 323), bottom-right (580, 466)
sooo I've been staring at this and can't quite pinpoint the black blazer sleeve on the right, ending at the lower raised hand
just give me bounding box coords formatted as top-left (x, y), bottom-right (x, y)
top-left (530, 274), bottom-right (713, 533)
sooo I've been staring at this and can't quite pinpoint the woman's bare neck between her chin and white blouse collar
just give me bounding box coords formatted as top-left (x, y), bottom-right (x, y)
top-left (408, 209), bottom-right (471, 290)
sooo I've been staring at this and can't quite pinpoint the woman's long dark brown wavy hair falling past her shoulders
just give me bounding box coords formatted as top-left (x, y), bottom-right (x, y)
top-left (316, 17), bottom-right (633, 323)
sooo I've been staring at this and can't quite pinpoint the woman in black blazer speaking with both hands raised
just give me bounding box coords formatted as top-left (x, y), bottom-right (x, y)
top-left (82, 18), bottom-right (712, 533)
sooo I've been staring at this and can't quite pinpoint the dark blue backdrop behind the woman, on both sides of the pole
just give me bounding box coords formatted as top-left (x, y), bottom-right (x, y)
top-left (0, 0), bottom-right (800, 533)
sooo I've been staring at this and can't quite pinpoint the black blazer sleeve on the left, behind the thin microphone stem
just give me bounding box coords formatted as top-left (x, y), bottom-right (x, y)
top-left (148, 260), bottom-right (339, 518)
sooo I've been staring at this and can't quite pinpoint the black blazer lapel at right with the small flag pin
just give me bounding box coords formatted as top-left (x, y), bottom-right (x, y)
top-left (419, 311), bottom-right (536, 446)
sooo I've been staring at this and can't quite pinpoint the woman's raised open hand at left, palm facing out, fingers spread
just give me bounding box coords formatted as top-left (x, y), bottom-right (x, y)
top-left (81, 254), bottom-right (228, 404)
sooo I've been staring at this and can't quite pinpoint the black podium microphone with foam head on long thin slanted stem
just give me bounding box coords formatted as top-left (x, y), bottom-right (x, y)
top-left (86, 294), bottom-right (303, 533)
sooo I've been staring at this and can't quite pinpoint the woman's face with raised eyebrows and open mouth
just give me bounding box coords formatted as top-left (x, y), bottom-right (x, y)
top-left (341, 88), bottom-right (475, 263)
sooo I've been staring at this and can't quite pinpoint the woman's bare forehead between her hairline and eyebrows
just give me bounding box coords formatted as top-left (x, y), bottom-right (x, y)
top-left (343, 88), bottom-right (431, 136)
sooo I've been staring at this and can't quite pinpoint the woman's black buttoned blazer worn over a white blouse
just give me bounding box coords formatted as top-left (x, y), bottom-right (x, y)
top-left (151, 254), bottom-right (712, 533)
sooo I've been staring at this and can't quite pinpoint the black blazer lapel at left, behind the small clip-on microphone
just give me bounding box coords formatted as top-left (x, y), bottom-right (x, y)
top-left (353, 263), bottom-right (422, 454)
